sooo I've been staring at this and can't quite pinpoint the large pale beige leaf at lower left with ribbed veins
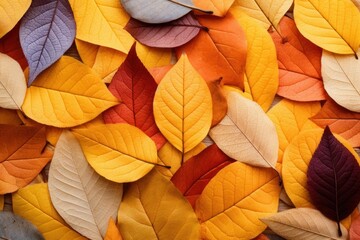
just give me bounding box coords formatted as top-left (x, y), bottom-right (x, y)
top-left (48, 131), bottom-right (122, 239)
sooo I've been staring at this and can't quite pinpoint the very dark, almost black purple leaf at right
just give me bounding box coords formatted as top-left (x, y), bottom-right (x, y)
top-left (307, 127), bottom-right (360, 236)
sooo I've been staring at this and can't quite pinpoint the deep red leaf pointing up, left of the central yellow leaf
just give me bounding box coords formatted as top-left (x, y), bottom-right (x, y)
top-left (103, 44), bottom-right (166, 149)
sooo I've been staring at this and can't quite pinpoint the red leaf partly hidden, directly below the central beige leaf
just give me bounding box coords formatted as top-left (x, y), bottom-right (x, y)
top-left (171, 144), bottom-right (235, 208)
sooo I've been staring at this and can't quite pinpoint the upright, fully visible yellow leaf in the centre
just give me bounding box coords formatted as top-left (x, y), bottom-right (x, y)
top-left (154, 55), bottom-right (212, 153)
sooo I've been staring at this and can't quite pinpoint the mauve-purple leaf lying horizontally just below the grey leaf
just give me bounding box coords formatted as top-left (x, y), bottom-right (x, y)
top-left (125, 13), bottom-right (206, 48)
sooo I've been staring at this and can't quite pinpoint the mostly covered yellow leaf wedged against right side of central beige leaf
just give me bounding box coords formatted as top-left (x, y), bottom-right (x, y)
top-left (267, 99), bottom-right (321, 162)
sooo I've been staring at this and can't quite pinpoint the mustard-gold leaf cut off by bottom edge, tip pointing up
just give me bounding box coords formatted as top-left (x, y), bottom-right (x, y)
top-left (118, 170), bottom-right (200, 240)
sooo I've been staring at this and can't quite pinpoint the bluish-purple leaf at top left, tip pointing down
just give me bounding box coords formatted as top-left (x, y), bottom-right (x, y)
top-left (20, 0), bottom-right (75, 86)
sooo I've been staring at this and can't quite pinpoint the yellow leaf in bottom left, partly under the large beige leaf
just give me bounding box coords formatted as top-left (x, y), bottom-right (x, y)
top-left (13, 183), bottom-right (85, 240)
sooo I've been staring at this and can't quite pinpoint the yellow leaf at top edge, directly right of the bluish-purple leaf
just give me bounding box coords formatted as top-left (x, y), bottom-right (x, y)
top-left (69, 0), bottom-right (134, 53)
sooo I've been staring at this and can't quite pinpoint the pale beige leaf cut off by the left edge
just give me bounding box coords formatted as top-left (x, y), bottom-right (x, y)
top-left (0, 53), bottom-right (26, 109)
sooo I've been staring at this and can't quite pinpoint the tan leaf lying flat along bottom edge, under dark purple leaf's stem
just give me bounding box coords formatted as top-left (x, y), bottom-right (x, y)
top-left (261, 208), bottom-right (348, 240)
